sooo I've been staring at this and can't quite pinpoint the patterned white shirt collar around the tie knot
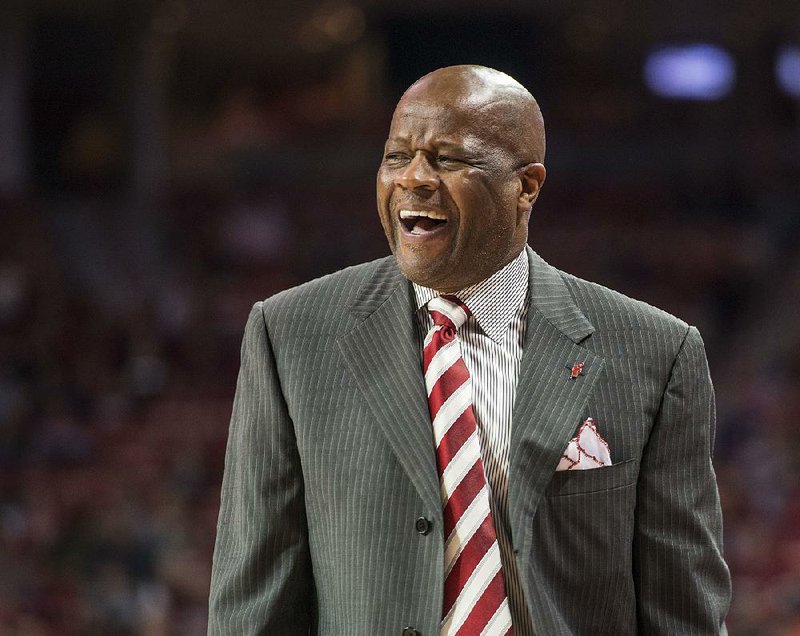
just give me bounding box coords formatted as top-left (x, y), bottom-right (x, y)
top-left (413, 250), bottom-right (529, 342)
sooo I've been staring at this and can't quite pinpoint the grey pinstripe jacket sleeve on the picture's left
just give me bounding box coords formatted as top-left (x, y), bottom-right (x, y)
top-left (208, 303), bottom-right (313, 635)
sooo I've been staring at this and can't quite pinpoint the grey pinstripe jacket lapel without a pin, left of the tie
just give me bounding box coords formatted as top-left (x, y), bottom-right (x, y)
top-left (338, 258), bottom-right (441, 514)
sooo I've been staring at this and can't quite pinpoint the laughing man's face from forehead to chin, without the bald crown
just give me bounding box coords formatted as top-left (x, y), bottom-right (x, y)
top-left (377, 95), bottom-right (530, 292)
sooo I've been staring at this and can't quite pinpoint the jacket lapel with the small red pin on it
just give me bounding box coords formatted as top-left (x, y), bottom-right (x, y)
top-left (509, 248), bottom-right (603, 554)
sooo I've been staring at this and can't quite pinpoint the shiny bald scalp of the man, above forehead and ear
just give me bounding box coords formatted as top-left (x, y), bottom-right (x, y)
top-left (396, 64), bottom-right (545, 163)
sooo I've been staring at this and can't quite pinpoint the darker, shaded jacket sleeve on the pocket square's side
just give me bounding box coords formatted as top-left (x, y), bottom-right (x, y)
top-left (633, 327), bottom-right (730, 635)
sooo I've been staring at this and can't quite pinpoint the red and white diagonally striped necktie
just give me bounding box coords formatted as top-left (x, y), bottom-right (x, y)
top-left (423, 296), bottom-right (513, 636)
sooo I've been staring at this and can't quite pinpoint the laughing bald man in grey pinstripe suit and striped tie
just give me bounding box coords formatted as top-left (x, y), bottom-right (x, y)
top-left (209, 66), bottom-right (730, 636)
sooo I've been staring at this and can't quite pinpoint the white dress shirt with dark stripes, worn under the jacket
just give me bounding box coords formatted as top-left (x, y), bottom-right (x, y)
top-left (414, 250), bottom-right (533, 636)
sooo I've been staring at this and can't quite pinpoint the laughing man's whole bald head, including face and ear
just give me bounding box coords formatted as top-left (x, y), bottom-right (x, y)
top-left (377, 66), bottom-right (546, 293)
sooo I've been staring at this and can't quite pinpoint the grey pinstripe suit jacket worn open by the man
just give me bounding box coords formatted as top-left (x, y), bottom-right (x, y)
top-left (209, 249), bottom-right (730, 636)
